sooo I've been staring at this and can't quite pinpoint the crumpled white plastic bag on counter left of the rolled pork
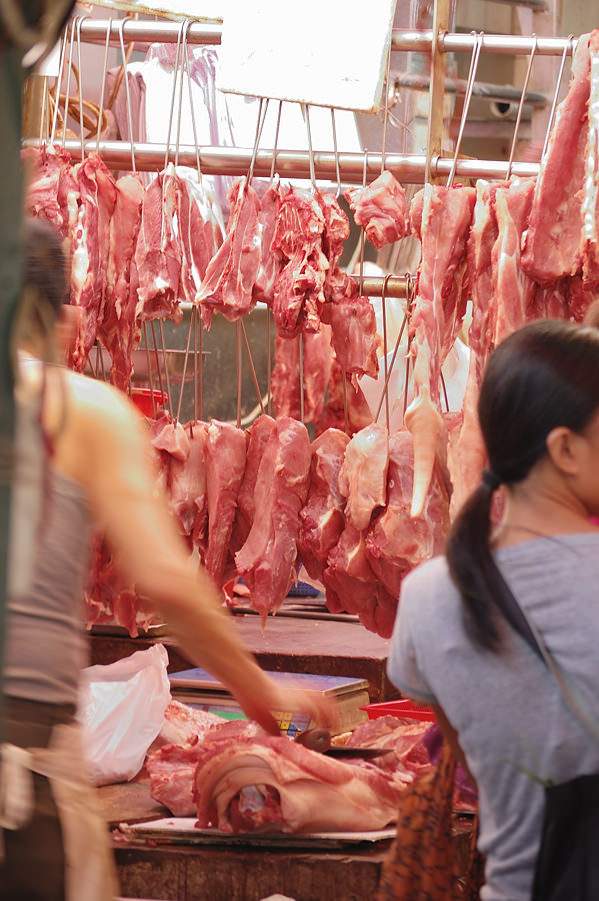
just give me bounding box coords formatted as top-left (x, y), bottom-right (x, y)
top-left (79, 644), bottom-right (171, 785)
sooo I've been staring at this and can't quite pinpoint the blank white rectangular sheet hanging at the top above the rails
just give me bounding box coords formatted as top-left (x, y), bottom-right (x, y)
top-left (217, 0), bottom-right (395, 112)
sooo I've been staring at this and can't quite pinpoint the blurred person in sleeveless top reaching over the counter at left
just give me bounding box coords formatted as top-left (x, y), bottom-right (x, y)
top-left (0, 220), bottom-right (335, 901)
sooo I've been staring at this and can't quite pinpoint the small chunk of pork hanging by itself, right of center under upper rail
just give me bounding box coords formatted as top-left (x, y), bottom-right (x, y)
top-left (345, 170), bottom-right (410, 250)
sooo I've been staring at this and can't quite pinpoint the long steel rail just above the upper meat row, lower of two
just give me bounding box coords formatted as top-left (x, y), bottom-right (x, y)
top-left (23, 138), bottom-right (539, 184)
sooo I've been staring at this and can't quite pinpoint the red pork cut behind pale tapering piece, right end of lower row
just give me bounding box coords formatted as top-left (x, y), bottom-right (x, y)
top-left (366, 429), bottom-right (449, 598)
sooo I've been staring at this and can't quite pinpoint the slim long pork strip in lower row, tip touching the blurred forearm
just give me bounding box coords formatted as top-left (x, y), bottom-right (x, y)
top-left (205, 419), bottom-right (246, 587)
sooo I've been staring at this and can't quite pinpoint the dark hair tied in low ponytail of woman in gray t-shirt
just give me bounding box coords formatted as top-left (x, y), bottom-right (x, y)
top-left (446, 320), bottom-right (599, 648)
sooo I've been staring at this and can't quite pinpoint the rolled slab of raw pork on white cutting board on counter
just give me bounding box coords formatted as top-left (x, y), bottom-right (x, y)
top-left (194, 723), bottom-right (406, 833)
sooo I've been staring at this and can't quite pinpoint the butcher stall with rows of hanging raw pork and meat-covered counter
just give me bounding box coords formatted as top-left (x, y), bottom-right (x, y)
top-left (17, 0), bottom-right (599, 901)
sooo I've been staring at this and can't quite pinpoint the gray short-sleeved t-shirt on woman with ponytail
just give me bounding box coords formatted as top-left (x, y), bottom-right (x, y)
top-left (387, 533), bottom-right (599, 901)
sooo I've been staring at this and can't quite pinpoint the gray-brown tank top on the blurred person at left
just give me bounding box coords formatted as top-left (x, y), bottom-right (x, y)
top-left (4, 376), bottom-right (90, 704)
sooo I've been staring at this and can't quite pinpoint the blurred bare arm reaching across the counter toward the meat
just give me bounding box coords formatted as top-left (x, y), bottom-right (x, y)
top-left (69, 379), bottom-right (334, 733)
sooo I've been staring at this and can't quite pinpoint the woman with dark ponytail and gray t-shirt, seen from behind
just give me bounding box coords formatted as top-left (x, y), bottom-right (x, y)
top-left (388, 320), bottom-right (599, 901)
